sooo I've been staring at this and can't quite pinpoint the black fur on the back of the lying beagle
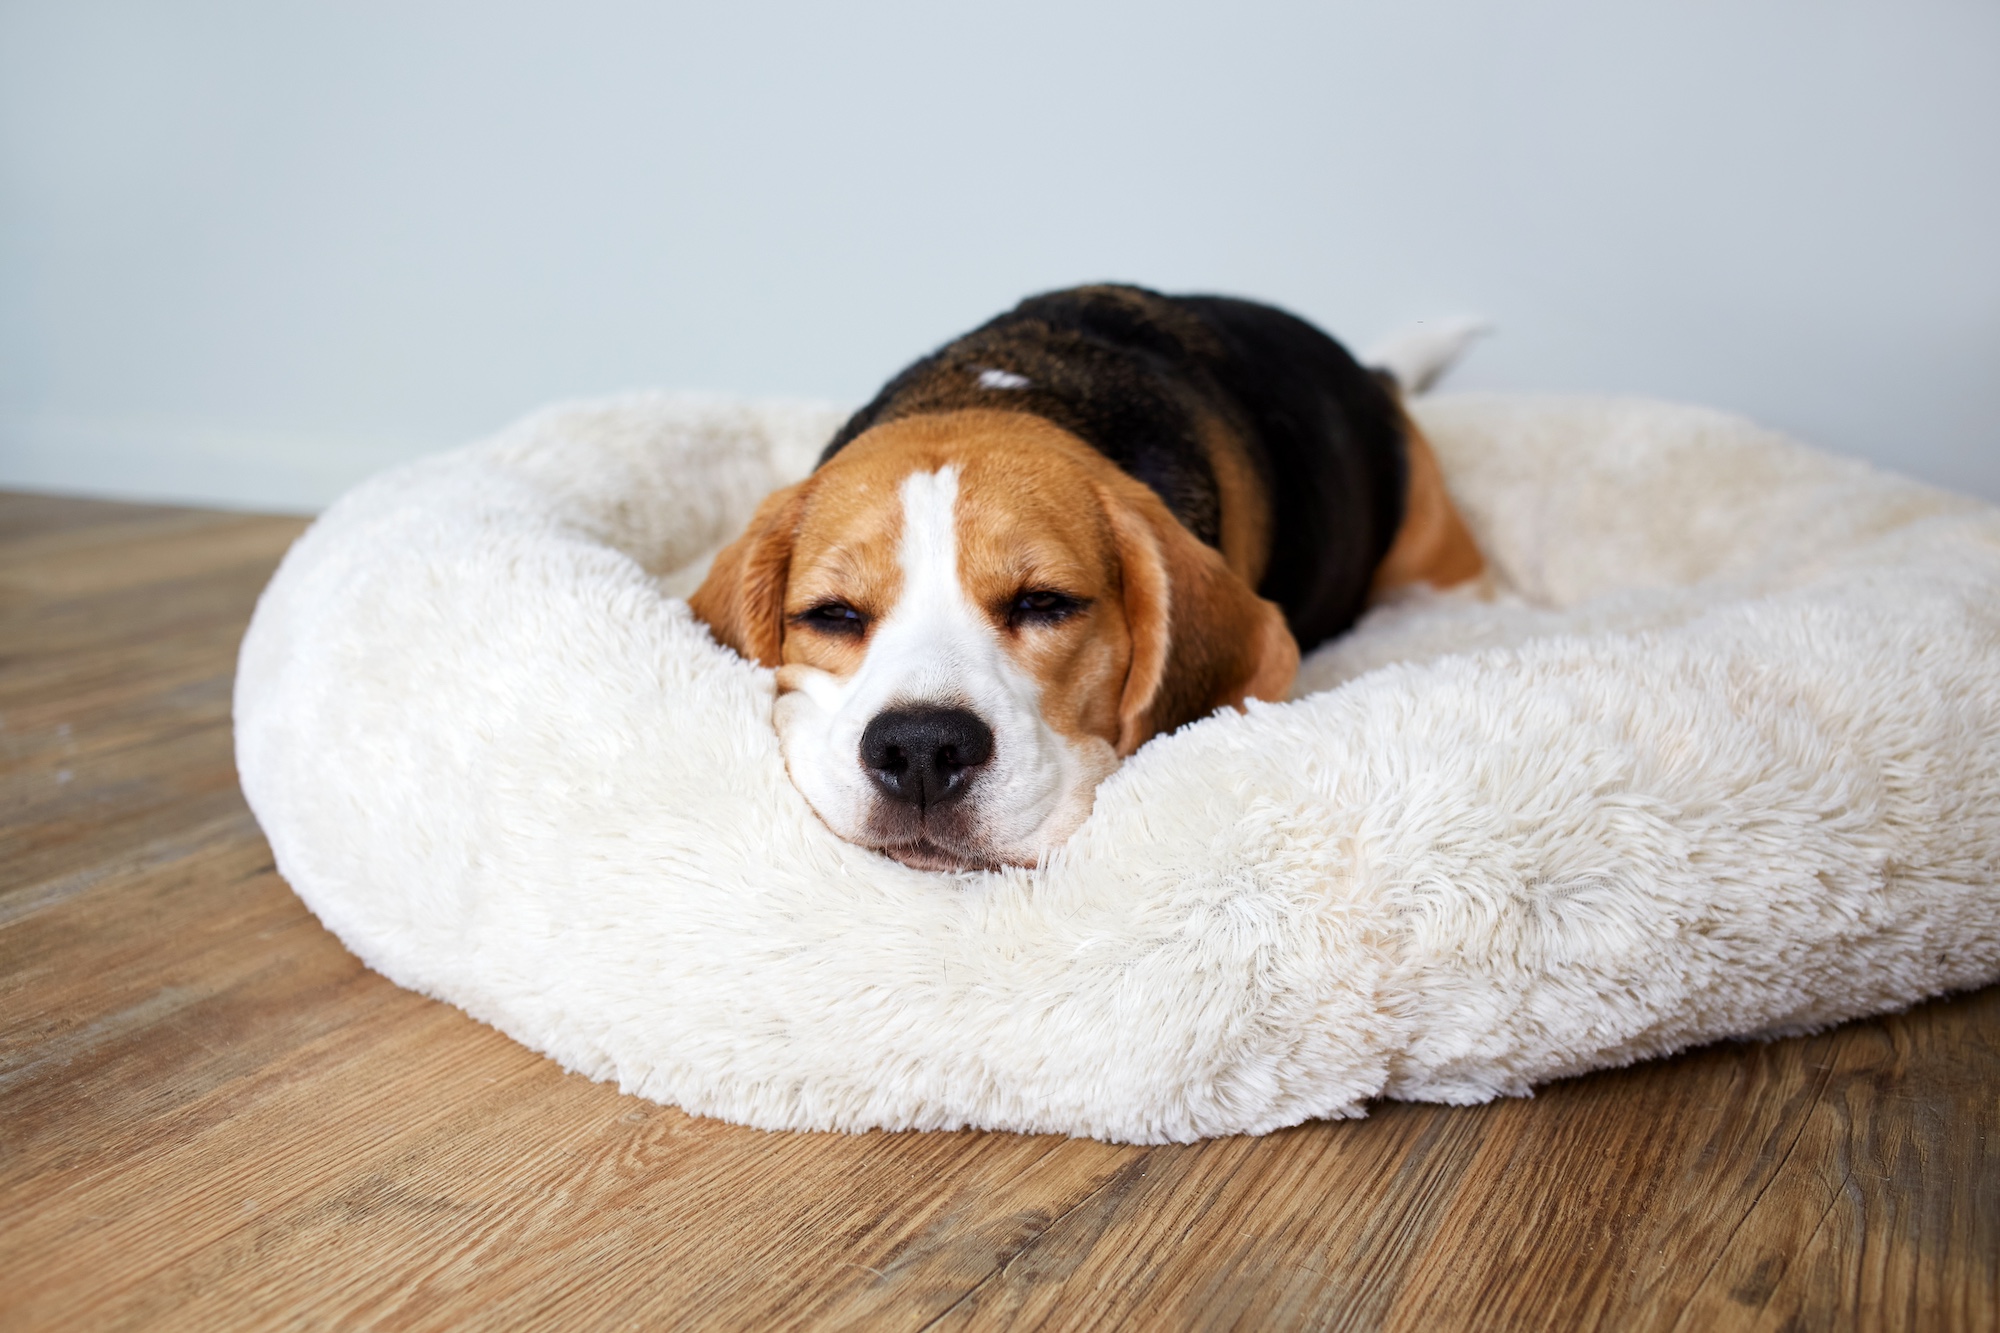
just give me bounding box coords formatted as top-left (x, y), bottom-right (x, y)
top-left (820, 286), bottom-right (1408, 650)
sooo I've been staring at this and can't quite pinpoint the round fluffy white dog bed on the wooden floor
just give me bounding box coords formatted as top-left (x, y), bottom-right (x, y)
top-left (236, 396), bottom-right (2000, 1143)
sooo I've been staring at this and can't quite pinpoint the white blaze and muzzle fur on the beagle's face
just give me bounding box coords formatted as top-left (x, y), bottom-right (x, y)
top-left (778, 466), bottom-right (1116, 861)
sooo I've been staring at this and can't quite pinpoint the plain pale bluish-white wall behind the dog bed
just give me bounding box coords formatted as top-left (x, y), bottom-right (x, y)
top-left (0, 0), bottom-right (2000, 506)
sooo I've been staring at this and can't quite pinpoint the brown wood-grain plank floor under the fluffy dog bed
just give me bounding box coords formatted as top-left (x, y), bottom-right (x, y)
top-left (0, 496), bottom-right (2000, 1329)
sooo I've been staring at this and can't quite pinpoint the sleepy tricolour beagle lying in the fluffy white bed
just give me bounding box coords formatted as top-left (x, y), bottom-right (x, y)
top-left (690, 286), bottom-right (1484, 871)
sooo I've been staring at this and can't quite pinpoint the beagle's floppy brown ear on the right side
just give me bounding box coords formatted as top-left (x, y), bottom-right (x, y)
top-left (1100, 482), bottom-right (1298, 755)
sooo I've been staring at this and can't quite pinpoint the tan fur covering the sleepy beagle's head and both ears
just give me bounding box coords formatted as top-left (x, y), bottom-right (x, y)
top-left (690, 410), bottom-right (1298, 755)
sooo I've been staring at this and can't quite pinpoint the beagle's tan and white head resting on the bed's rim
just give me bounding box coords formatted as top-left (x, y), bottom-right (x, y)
top-left (690, 410), bottom-right (1298, 869)
